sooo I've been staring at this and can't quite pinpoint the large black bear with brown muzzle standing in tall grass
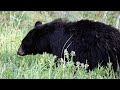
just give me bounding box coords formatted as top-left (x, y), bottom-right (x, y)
top-left (18, 18), bottom-right (120, 70)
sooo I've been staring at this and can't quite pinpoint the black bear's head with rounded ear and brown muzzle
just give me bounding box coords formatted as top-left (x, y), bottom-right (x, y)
top-left (17, 21), bottom-right (51, 56)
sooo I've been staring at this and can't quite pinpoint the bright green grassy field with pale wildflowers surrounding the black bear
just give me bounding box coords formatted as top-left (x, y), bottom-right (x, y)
top-left (0, 11), bottom-right (120, 79)
